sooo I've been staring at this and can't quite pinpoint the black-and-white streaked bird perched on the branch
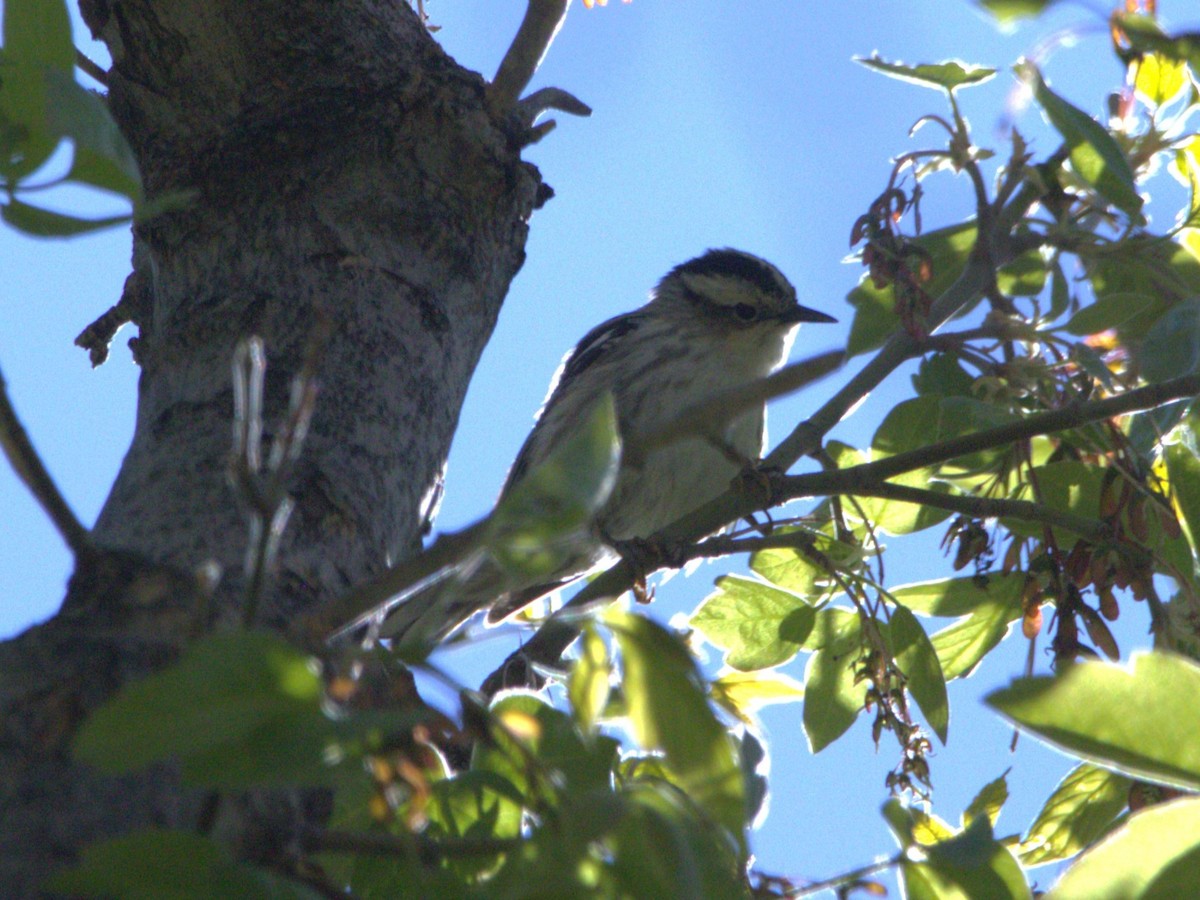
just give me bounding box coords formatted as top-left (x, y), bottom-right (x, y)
top-left (364, 248), bottom-right (835, 643)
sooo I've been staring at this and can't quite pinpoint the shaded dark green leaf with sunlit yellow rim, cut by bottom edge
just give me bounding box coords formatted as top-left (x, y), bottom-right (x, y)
top-left (900, 816), bottom-right (1030, 900)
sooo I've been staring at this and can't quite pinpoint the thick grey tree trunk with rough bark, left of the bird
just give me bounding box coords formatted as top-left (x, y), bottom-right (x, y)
top-left (0, 0), bottom-right (542, 896)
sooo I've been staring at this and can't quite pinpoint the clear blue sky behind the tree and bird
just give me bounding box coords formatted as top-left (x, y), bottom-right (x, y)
top-left (0, 0), bottom-right (1196, 887)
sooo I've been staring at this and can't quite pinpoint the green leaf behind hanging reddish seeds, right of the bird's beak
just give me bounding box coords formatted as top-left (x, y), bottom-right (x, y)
top-left (846, 222), bottom-right (976, 356)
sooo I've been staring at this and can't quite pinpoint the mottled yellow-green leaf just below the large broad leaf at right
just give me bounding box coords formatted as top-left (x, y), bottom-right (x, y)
top-left (1020, 762), bottom-right (1133, 866)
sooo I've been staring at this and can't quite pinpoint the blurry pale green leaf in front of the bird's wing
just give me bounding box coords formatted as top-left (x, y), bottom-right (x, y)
top-left (487, 394), bottom-right (620, 577)
